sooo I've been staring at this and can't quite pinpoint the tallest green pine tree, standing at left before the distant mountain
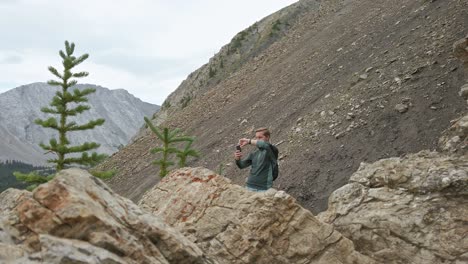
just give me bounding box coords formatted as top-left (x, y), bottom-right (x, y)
top-left (15, 41), bottom-right (106, 188)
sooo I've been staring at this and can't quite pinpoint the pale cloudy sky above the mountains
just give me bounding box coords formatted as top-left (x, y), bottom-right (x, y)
top-left (0, 0), bottom-right (297, 105)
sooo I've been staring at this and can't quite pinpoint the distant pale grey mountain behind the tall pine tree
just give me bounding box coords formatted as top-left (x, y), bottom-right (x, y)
top-left (0, 83), bottom-right (159, 165)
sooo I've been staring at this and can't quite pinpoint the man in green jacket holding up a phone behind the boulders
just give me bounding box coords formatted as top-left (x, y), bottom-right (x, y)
top-left (234, 128), bottom-right (278, 192)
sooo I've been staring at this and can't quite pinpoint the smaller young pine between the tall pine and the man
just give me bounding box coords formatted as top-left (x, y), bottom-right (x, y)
top-left (145, 117), bottom-right (199, 178)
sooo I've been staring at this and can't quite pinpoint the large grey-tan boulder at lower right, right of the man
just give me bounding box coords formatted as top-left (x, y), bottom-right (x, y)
top-left (318, 151), bottom-right (468, 264)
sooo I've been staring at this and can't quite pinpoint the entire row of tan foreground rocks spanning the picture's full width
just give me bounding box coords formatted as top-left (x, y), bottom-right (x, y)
top-left (0, 154), bottom-right (468, 264)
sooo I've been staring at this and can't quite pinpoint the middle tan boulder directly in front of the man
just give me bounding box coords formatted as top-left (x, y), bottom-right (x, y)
top-left (139, 168), bottom-right (375, 264)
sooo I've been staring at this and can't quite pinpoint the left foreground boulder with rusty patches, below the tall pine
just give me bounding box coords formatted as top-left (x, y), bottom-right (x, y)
top-left (0, 169), bottom-right (215, 263)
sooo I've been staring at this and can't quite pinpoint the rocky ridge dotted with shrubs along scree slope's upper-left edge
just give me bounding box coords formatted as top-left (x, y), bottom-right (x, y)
top-left (151, 0), bottom-right (326, 127)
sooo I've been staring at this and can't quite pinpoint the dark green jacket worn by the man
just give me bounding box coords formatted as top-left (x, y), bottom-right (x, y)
top-left (236, 140), bottom-right (275, 190)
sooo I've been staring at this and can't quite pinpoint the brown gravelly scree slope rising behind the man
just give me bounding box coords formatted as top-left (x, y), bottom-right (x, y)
top-left (98, 0), bottom-right (468, 213)
